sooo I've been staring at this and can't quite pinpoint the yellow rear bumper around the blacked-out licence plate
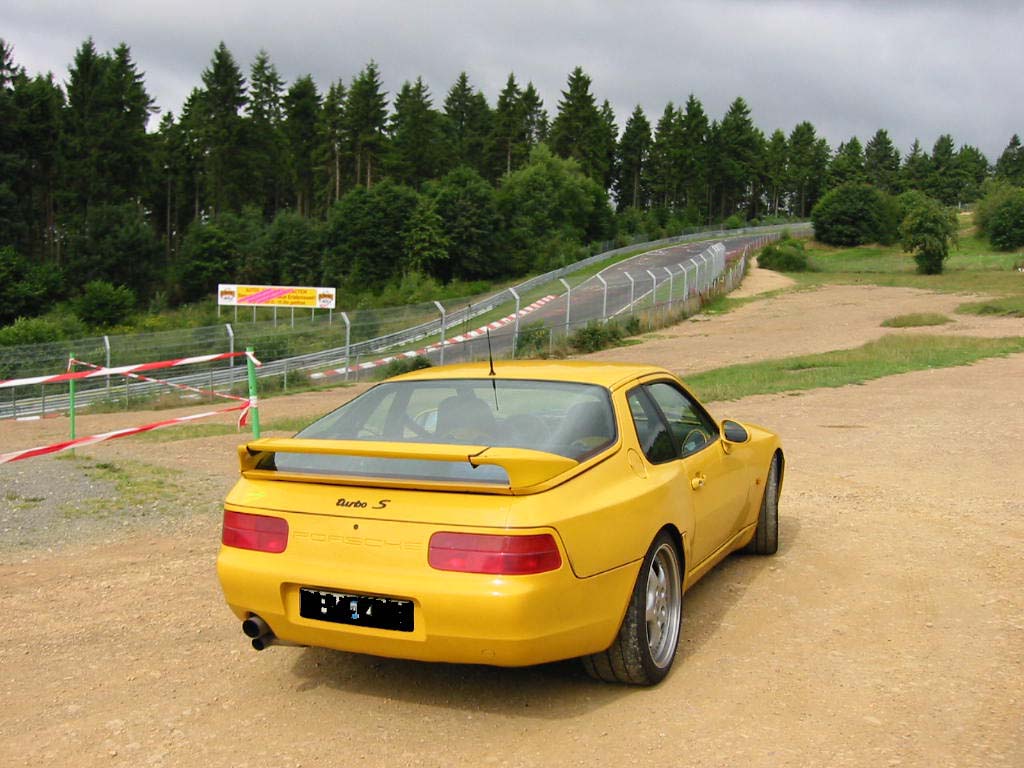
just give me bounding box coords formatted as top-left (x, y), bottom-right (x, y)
top-left (217, 547), bottom-right (639, 667)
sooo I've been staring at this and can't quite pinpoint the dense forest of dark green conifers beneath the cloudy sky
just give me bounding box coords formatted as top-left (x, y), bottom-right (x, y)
top-left (0, 39), bottom-right (1024, 335)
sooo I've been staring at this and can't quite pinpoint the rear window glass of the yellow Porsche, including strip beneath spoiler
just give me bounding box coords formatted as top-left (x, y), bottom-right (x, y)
top-left (266, 379), bottom-right (617, 483)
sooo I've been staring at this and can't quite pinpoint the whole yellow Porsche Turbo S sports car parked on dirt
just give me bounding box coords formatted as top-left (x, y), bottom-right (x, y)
top-left (217, 361), bottom-right (785, 685)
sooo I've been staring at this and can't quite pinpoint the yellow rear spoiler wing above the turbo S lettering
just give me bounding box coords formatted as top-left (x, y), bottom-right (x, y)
top-left (239, 437), bottom-right (580, 494)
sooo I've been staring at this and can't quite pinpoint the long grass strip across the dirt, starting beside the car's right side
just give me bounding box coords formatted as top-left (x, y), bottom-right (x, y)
top-left (687, 335), bottom-right (1024, 401)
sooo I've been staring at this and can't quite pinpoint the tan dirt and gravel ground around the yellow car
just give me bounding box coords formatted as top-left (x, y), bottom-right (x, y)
top-left (0, 270), bottom-right (1024, 768)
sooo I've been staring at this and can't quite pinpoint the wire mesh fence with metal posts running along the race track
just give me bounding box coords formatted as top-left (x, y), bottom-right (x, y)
top-left (0, 226), bottom-right (799, 419)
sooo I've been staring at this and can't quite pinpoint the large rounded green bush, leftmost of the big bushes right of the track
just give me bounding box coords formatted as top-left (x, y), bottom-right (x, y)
top-left (811, 183), bottom-right (899, 246)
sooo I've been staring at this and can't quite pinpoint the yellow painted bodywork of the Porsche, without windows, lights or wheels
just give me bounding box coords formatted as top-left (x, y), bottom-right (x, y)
top-left (211, 362), bottom-right (781, 666)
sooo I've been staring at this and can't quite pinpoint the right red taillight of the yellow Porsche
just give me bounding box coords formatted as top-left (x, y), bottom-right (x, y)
top-left (428, 531), bottom-right (562, 575)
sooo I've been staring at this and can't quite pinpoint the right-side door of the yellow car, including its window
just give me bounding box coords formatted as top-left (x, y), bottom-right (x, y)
top-left (644, 381), bottom-right (746, 566)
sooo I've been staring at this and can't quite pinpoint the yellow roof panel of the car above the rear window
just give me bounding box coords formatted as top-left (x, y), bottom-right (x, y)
top-left (388, 360), bottom-right (671, 389)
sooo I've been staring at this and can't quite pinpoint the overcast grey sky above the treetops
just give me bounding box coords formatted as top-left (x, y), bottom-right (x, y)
top-left (0, 0), bottom-right (1024, 163)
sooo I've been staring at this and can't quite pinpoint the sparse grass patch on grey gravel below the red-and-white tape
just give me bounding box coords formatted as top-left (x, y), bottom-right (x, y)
top-left (60, 459), bottom-right (182, 519)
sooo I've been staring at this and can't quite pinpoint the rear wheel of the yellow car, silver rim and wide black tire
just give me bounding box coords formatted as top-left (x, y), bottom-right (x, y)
top-left (583, 530), bottom-right (683, 685)
